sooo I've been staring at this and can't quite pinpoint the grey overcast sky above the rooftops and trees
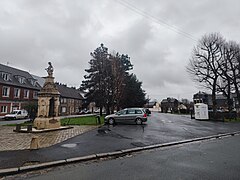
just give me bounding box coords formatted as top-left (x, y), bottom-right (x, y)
top-left (0, 0), bottom-right (240, 101)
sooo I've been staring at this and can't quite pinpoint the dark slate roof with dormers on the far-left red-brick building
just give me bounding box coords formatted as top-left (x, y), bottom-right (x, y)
top-left (0, 64), bottom-right (40, 90)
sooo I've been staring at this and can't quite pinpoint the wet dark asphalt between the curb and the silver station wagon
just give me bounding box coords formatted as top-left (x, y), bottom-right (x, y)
top-left (0, 113), bottom-right (240, 169)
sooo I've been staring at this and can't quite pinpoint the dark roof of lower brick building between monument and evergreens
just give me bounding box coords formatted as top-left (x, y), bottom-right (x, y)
top-left (56, 83), bottom-right (84, 100)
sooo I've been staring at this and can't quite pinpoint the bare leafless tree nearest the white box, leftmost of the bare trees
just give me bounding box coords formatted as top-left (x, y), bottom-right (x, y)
top-left (187, 33), bottom-right (225, 115)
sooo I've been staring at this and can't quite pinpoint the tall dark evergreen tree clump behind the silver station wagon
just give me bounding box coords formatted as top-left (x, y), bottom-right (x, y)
top-left (81, 44), bottom-right (145, 114)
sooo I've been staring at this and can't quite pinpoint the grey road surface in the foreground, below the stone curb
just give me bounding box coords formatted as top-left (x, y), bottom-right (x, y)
top-left (11, 135), bottom-right (240, 180)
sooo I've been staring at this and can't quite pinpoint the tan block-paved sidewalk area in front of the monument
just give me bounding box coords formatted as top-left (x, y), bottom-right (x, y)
top-left (0, 126), bottom-right (97, 151)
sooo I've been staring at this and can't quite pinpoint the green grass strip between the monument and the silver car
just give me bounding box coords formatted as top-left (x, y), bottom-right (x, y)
top-left (61, 116), bottom-right (104, 126)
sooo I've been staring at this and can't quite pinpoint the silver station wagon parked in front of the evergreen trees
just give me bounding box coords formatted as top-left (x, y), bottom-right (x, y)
top-left (105, 108), bottom-right (147, 125)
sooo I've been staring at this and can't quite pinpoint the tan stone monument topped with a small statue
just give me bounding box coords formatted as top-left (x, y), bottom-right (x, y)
top-left (34, 62), bottom-right (61, 130)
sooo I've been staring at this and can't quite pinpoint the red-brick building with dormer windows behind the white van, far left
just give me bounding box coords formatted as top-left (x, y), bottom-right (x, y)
top-left (0, 64), bottom-right (41, 116)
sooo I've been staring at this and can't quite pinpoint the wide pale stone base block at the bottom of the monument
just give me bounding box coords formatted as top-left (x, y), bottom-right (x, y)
top-left (33, 117), bottom-right (61, 130)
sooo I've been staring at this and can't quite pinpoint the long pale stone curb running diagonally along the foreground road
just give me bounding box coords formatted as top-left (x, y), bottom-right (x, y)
top-left (0, 131), bottom-right (240, 177)
